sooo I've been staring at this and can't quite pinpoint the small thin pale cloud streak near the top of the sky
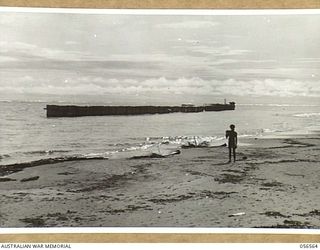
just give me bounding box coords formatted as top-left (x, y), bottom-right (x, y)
top-left (156, 21), bottom-right (219, 29)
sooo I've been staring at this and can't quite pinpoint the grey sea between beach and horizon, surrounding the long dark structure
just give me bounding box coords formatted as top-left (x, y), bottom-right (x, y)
top-left (0, 102), bottom-right (320, 165)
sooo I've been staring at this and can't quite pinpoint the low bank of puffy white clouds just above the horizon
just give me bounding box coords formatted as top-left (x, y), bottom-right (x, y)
top-left (0, 75), bottom-right (320, 99)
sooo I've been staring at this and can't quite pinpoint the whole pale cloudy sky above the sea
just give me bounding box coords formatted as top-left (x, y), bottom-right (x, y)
top-left (0, 12), bottom-right (320, 102)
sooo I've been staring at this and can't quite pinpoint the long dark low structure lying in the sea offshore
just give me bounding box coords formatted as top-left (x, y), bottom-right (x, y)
top-left (45, 102), bottom-right (235, 117)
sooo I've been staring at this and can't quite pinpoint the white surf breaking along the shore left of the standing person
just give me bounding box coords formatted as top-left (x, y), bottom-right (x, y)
top-left (0, 136), bottom-right (226, 171)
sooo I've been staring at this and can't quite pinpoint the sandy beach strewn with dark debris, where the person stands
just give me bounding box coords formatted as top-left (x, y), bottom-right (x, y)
top-left (0, 135), bottom-right (320, 228)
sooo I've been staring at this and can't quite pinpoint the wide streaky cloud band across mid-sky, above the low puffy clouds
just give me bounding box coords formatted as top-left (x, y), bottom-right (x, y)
top-left (0, 40), bottom-right (319, 80)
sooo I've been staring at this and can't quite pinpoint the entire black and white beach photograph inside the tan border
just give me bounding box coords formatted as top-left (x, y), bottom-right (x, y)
top-left (0, 8), bottom-right (320, 230)
